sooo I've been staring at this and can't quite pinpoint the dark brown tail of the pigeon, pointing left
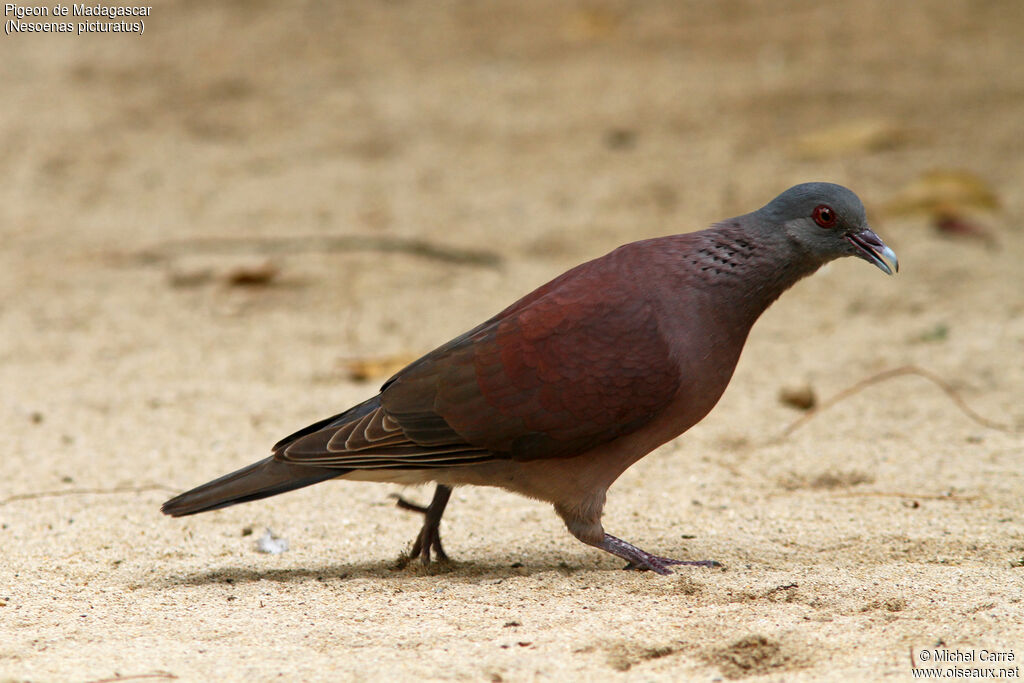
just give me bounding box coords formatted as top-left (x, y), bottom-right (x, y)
top-left (160, 456), bottom-right (348, 517)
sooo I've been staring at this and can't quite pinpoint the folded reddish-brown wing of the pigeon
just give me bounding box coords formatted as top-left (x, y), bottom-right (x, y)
top-left (275, 250), bottom-right (680, 469)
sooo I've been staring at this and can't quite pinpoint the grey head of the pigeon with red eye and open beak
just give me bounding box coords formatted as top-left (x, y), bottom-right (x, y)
top-left (755, 182), bottom-right (899, 275)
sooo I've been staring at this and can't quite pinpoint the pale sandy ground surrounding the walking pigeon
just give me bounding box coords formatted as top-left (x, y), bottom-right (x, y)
top-left (0, 0), bottom-right (1024, 681)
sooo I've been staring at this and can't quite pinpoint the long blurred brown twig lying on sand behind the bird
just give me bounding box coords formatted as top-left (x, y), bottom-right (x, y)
top-left (120, 234), bottom-right (502, 266)
